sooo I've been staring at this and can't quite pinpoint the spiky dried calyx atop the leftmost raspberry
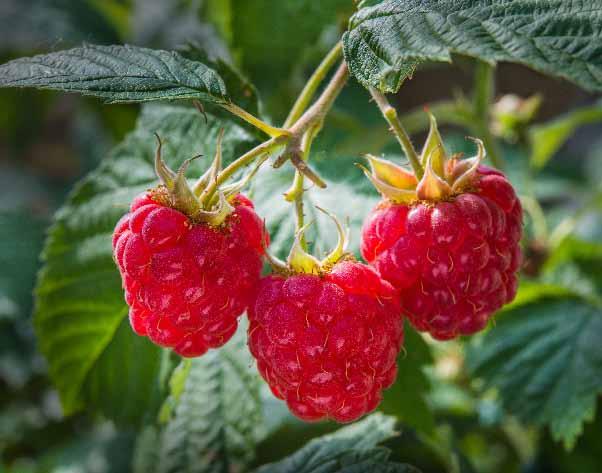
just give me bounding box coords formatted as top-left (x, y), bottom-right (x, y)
top-left (151, 130), bottom-right (267, 227)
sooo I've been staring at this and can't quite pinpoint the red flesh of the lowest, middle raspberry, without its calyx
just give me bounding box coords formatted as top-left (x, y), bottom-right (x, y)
top-left (248, 261), bottom-right (403, 422)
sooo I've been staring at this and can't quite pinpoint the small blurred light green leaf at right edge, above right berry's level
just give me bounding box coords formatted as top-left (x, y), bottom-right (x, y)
top-left (529, 102), bottom-right (602, 169)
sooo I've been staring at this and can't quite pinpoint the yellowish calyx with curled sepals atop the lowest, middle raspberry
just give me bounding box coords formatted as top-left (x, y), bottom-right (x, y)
top-left (266, 207), bottom-right (353, 276)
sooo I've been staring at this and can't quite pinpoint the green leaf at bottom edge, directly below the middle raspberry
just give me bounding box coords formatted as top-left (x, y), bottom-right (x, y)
top-left (257, 413), bottom-right (403, 473)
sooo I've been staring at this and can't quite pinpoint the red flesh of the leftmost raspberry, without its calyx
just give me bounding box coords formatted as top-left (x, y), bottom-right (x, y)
top-left (113, 194), bottom-right (267, 357)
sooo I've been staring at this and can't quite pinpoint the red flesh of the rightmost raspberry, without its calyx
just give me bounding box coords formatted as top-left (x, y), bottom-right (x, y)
top-left (361, 166), bottom-right (522, 340)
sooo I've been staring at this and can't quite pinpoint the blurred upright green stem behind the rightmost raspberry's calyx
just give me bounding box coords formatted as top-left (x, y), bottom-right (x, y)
top-left (470, 61), bottom-right (504, 169)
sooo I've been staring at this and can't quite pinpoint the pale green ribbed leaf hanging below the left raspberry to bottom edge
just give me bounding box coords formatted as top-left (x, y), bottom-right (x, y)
top-left (154, 324), bottom-right (264, 473)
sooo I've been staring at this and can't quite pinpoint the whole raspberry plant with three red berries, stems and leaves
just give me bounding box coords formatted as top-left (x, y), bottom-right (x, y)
top-left (0, 0), bottom-right (602, 473)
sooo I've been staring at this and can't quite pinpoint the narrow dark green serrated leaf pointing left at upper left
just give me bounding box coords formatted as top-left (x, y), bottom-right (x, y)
top-left (0, 45), bottom-right (226, 103)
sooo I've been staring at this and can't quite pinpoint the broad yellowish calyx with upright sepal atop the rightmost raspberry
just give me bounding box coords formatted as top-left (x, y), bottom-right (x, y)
top-left (360, 114), bottom-right (485, 204)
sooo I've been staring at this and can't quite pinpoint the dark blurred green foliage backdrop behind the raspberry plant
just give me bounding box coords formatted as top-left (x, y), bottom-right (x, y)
top-left (0, 0), bottom-right (602, 473)
